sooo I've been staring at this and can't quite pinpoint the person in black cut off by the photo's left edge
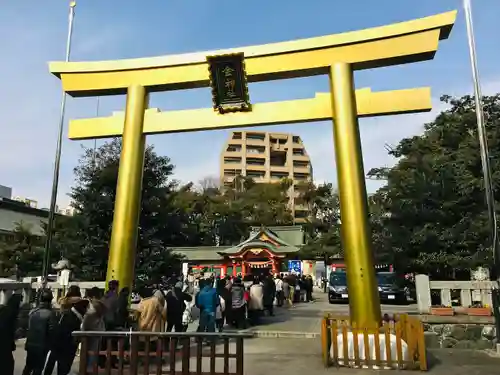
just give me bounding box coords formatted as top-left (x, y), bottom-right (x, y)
top-left (0, 294), bottom-right (21, 375)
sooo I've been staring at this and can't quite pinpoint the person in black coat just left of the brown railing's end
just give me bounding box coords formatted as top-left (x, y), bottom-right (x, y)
top-left (44, 299), bottom-right (90, 375)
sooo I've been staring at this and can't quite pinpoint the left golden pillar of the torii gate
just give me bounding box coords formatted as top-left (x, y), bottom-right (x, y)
top-left (106, 86), bottom-right (148, 288)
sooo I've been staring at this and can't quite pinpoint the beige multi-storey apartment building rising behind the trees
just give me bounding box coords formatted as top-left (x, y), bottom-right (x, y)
top-left (220, 131), bottom-right (313, 222)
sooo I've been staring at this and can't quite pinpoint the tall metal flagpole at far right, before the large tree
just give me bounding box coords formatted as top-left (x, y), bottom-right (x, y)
top-left (463, 0), bottom-right (500, 339)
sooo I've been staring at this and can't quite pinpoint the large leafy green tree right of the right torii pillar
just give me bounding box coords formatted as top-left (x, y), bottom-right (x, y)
top-left (369, 95), bottom-right (500, 277)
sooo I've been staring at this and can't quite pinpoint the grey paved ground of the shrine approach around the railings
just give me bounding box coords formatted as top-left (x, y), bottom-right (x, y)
top-left (24, 292), bottom-right (500, 375)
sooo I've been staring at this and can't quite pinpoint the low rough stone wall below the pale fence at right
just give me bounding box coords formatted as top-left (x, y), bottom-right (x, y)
top-left (424, 323), bottom-right (497, 350)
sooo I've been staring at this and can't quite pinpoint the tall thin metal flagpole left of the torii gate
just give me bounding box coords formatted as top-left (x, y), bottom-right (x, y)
top-left (42, 1), bottom-right (76, 285)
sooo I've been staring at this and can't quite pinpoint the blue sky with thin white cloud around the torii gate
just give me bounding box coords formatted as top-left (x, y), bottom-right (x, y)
top-left (0, 0), bottom-right (500, 206)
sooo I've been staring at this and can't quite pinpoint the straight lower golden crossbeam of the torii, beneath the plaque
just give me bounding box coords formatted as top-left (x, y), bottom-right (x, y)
top-left (69, 87), bottom-right (432, 140)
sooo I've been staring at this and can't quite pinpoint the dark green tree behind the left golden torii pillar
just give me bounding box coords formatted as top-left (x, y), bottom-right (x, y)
top-left (67, 139), bottom-right (184, 282)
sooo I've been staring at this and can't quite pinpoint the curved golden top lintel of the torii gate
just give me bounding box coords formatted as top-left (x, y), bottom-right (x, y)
top-left (50, 11), bottom-right (456, 96)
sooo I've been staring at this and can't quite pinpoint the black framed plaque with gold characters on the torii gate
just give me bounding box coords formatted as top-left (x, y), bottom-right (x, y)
top-left (207, 53), bottom-right (251, 114)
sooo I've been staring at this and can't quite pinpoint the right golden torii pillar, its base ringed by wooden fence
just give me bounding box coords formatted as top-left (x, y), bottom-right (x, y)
top-left (330, 63), bottom-right (381, 327)
